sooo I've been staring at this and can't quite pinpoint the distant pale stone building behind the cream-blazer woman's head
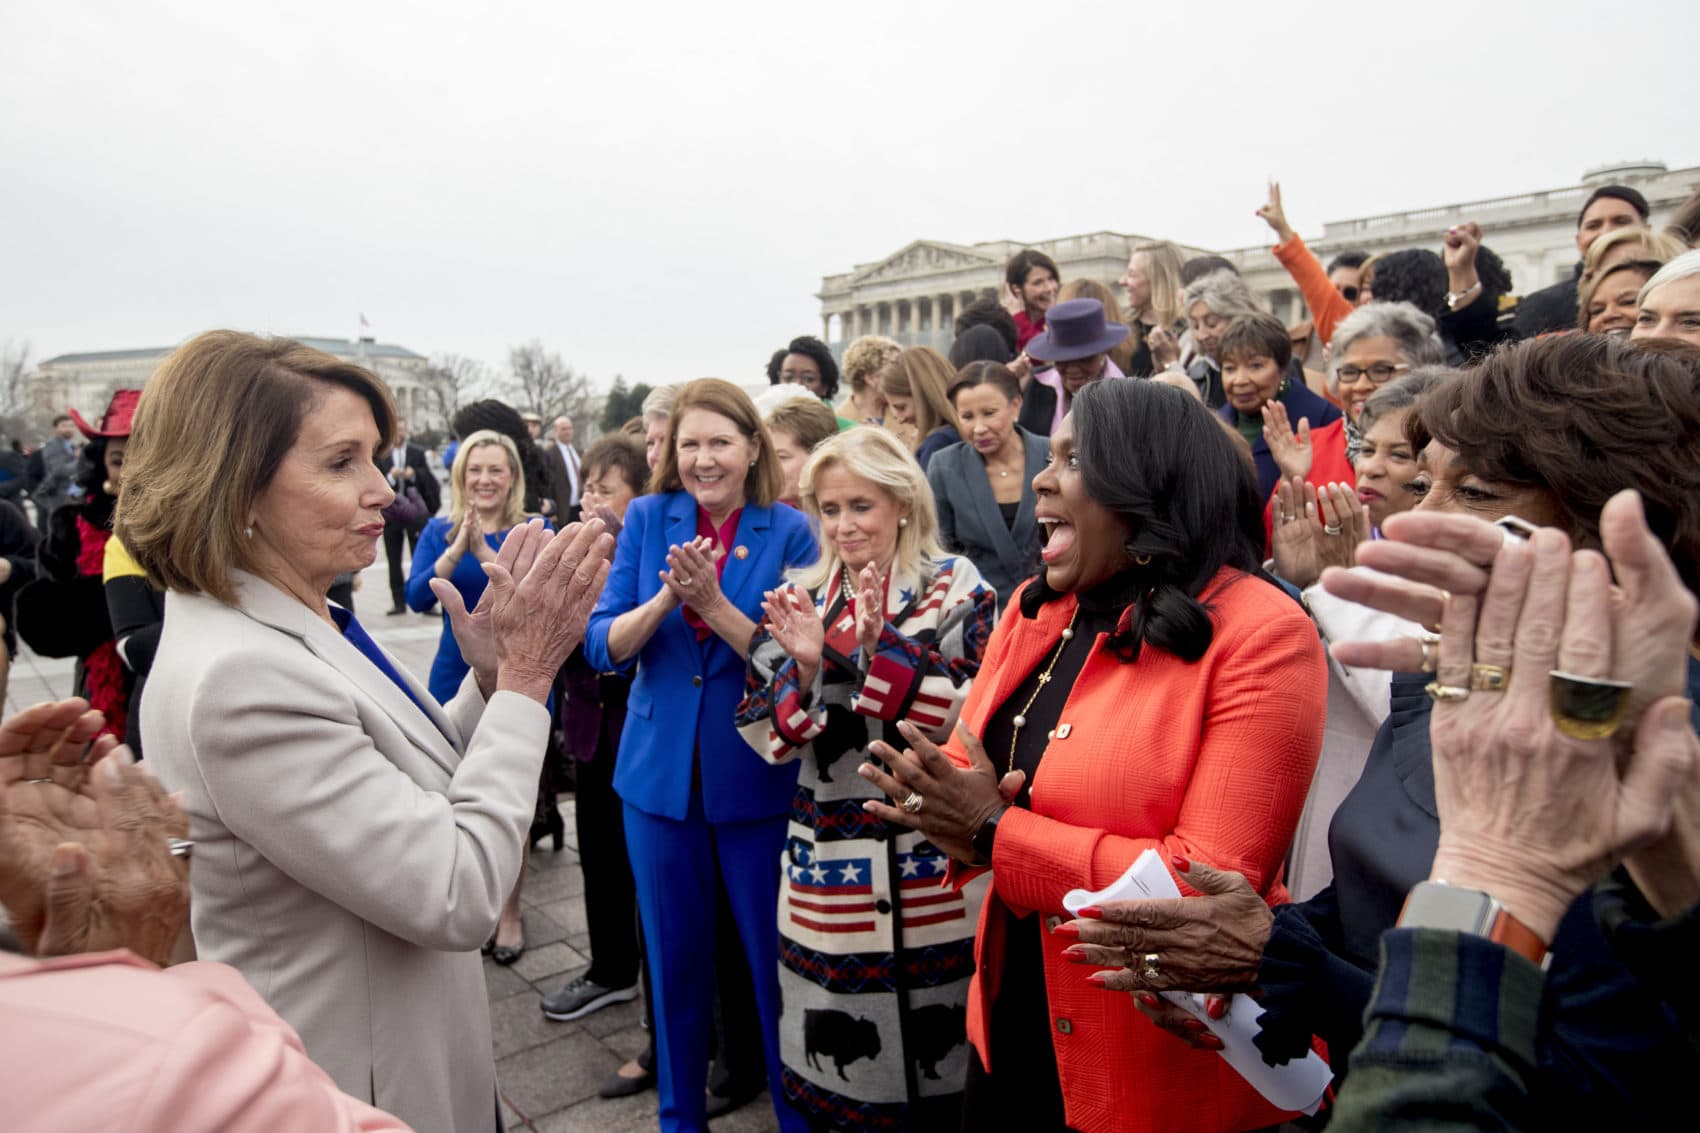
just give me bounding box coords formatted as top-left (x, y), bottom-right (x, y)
top-left (24, 337), bottom-right (454, 432)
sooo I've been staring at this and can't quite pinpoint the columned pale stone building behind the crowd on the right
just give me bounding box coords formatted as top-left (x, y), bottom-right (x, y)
top-left (816, 162), bottom-right (1700, 356)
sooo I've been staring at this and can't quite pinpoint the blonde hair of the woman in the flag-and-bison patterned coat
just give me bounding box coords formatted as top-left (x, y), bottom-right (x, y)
top-left (791, 429), bottom-right (944, 592)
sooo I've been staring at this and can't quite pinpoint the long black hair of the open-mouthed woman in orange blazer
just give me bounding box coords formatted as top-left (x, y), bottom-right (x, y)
top-left (1073, 381), bottom-right (1265, 662)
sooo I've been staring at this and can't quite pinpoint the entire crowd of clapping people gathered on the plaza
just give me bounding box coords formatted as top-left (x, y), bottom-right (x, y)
top-left (0, 178), bottom-right (1700, 1133)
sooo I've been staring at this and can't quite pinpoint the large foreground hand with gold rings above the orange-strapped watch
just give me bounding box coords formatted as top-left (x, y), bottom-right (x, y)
top-left (1430, 497), bottom-right (1700, 942)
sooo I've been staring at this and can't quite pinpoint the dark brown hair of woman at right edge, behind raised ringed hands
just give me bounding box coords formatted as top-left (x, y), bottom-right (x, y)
top-left (1421, 335), bottom-right (1700, 592)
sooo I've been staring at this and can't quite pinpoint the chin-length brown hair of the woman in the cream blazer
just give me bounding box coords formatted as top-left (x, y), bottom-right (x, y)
top-left (114, 330), bottom-right (396, 602)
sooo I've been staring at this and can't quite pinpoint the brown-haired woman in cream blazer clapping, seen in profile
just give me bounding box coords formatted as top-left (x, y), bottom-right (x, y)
top-left (119, 332), bottom-right (612, 1133)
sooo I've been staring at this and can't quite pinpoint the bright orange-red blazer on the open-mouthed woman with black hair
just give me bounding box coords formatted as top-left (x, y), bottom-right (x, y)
top-left (947, 570), bottom-right (1328, 1133)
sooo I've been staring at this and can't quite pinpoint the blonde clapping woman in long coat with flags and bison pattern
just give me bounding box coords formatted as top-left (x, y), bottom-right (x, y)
top-left (738, 429), bottom-right (998, 1130)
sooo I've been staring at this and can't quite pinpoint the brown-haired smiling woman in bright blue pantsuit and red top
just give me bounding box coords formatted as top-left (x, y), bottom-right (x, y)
top-left (585, 378), bottom-right (816, 1131)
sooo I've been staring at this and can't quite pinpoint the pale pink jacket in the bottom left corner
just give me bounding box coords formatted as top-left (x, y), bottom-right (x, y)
top-left (0, 951), bottom-right (411, 1133)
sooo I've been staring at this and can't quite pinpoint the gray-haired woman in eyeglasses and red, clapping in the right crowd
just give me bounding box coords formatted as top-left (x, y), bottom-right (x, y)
top-left (1263, 303), bottom-right (1445, 534)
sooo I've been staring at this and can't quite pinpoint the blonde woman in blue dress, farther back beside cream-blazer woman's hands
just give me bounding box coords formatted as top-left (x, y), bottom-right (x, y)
top-left (406, 429), bottom-right (549, 965)
